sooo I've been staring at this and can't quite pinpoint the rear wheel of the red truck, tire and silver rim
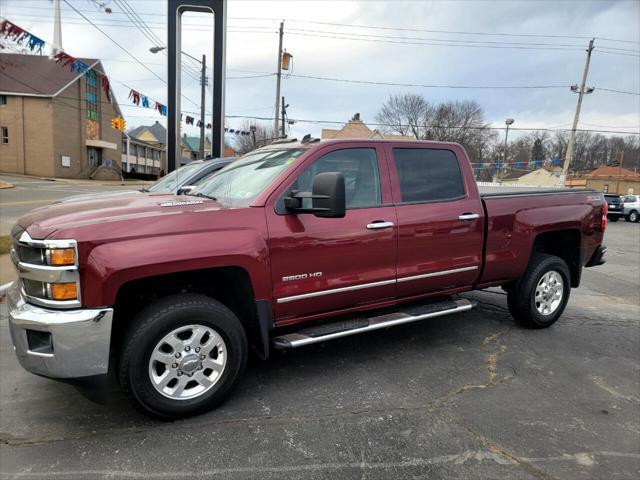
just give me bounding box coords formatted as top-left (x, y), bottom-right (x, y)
top-left (507, 253), bottom-right (571, 328)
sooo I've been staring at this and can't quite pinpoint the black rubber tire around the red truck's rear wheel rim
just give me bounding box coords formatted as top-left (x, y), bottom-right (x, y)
top-left (507, 253), bottom-right (571, 328)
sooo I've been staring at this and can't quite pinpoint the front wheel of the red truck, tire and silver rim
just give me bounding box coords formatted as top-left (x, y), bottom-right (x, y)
top-left (119, 294), bottom-right (247, 420)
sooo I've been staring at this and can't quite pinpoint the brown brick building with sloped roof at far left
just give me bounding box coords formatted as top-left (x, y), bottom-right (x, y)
top-left (0, 53), bottom-right (122, 179)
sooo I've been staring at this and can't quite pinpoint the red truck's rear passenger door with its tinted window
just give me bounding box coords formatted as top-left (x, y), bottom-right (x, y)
top-left (387, 144), bottom-right (484, 297)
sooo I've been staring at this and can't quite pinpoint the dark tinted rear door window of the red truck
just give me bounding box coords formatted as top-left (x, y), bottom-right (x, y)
top-left (393, 148), bottom-right (464, 202)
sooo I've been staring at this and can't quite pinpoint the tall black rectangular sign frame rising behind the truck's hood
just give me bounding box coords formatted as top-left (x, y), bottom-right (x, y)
top-left (167, 0), bottom-right (227, 172)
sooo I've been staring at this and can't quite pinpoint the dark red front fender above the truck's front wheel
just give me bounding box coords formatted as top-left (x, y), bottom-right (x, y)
top-left (81, 228), bottom-right (271, 307)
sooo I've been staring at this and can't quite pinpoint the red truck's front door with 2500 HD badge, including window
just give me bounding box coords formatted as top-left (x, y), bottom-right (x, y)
top-left (266, 142), bottom-right (397, 324)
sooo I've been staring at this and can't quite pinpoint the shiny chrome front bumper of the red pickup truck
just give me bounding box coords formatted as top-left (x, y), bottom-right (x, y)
top-left (6, 282), bottom-right (113, 378)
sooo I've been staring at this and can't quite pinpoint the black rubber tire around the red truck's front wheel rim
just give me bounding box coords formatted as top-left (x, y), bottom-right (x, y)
top-left (118, 294), bottom-right (247, 420)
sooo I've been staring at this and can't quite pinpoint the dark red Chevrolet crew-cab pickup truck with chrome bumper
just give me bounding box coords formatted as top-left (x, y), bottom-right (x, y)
top-left (7, 137), bottom-right (607, 418)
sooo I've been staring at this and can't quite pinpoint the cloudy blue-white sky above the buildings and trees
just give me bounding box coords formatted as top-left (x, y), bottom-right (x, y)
top-left (0, 0), bottom-right (640, 146)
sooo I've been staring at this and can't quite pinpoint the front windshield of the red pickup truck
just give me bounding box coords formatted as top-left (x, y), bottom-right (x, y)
top-left (190, 149), bottom-right (304, 208)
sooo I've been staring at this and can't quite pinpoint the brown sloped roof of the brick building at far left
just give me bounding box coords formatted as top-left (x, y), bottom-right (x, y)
top-left (0, 53), bottom-right (102, 97)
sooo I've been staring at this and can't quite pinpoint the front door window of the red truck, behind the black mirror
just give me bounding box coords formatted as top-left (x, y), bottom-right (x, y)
top-left (292, 148), bottom-right (382, 208)
